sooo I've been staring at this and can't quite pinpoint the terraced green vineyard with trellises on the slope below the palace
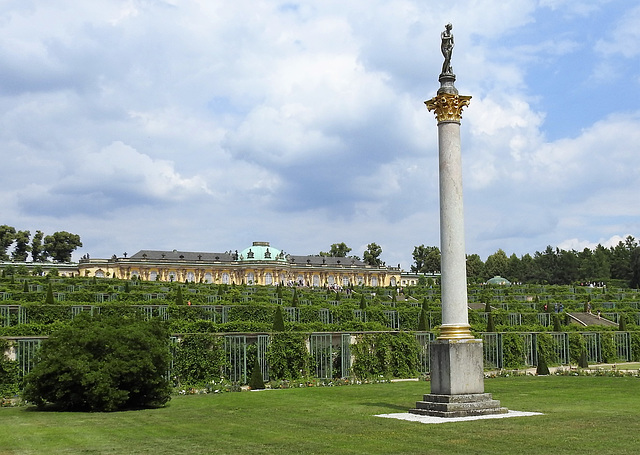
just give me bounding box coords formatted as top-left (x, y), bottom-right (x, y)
top-left (0, 276), bottom-right (640, 392)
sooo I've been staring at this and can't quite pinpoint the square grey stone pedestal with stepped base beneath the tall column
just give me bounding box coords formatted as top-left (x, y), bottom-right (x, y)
top-left (409, 339), bottom-right (507, 417)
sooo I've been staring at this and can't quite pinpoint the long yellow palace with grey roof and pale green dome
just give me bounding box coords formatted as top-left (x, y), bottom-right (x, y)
top-left (78, 242), bottom-right (400, 287)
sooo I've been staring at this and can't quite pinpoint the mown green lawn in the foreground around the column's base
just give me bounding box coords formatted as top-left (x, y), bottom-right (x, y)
top-left (0, 376), bottom-right (640, 455)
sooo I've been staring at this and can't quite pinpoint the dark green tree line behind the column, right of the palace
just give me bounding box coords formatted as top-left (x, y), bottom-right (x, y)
top-left (411, 236), bottom-right (640, 288)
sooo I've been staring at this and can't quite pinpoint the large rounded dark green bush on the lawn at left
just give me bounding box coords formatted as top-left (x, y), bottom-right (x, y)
top-left (23, 315), bottom-right (171, 411)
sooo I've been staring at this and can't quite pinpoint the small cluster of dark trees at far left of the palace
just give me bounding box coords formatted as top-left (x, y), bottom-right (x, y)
top-left (0, 224), bottom-right (82, 262)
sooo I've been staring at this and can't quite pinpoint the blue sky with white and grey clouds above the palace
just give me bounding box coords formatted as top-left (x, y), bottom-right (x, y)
top-left (0, 0), bottom-right (640, 269)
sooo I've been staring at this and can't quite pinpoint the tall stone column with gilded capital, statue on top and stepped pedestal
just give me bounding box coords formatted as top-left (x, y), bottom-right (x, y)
top-left (409, 24), bottom-right (507, 417)
